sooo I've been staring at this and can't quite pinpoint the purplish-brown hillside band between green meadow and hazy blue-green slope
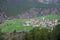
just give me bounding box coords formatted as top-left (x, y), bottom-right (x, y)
top-left (17, 8), bottom-right (60, 18)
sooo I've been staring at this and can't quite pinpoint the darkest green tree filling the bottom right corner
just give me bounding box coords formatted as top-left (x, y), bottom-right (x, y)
top-left (51, 24), bottom-right (60, 40)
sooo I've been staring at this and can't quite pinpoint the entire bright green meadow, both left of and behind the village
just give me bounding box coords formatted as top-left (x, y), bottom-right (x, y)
top-left (0, 15), bottom-right (60, 32)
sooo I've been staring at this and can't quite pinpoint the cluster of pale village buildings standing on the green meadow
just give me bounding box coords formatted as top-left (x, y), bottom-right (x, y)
top-left (23, 18), bottom-right (59, 27)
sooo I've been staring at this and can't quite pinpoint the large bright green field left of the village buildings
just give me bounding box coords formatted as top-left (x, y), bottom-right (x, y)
top-left (0, 19), bottom-right (32, 32)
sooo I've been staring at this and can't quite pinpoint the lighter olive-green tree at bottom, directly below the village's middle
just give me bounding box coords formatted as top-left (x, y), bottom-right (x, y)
top-left (32, 27), bottom-right (48, 40)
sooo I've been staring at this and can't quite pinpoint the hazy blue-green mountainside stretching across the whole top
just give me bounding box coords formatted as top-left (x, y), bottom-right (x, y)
top-left (0, 0), bottom-right (60, 16)
